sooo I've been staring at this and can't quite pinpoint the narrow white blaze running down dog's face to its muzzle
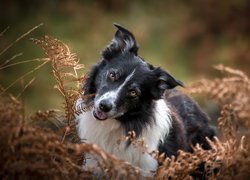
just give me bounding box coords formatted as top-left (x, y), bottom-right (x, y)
top-left (95, 69), bottom-right (135, 108)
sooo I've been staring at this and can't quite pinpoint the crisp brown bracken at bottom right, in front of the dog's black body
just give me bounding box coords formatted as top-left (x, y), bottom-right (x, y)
top-left (156, 138), bottom-right (240, 179)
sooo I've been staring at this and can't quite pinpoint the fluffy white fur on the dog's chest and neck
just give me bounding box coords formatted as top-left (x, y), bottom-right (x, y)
top-left (76, 99), bottom-right (171, 171)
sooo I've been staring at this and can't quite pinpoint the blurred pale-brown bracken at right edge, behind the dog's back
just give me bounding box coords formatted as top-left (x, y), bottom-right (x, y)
top-left (186, 65), bottom-right (250, 128)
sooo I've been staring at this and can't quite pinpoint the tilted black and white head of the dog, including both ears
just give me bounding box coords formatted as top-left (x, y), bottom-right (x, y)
top-left (84, 24), bottom-right (183, 120)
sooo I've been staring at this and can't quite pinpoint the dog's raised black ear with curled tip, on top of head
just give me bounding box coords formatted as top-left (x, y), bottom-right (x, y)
top-left (102, 24), bottom-right (138, 59)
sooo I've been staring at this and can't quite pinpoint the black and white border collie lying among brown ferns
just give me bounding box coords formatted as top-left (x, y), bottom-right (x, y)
top-left (76, 24), bottom-right (215, 171)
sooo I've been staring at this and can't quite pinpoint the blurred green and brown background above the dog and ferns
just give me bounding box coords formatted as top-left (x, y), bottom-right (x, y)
top-left (0, 0), bottom-right (250, 115)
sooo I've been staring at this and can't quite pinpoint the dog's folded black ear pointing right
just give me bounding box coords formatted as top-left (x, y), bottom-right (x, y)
top-left (152, 68), bottom-right (184, 99)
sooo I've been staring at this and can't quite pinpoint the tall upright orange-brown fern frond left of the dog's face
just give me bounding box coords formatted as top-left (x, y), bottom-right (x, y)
top-left (32, 36), bottom-right (83, 141)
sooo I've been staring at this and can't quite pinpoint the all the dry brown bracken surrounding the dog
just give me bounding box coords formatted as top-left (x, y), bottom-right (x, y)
top-left (0, 36), bottom-right (250, 179)
